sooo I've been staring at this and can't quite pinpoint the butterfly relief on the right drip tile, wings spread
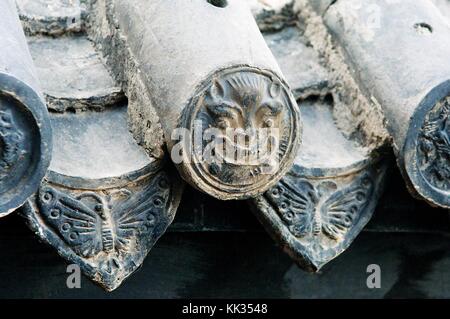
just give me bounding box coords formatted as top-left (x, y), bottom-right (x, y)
top-left (265, 175), bottom-right (373, 242)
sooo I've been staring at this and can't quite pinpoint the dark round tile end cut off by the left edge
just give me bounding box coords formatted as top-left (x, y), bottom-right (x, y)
top-left (0, 74), bottom-right (52, 217)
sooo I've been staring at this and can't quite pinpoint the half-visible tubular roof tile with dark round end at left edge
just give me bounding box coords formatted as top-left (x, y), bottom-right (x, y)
top-left (0, 0), bottom-right (52, 217)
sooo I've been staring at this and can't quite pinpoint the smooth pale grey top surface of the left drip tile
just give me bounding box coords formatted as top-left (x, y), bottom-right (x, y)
top-left (50, 105), bottom-right (153, 180)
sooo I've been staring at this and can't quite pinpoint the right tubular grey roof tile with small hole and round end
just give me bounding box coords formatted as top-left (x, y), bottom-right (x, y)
top-left (302, 0), bottom-right (450, 208)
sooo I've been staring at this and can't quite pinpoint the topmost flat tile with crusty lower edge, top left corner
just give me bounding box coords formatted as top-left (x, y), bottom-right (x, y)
top-left (16, 0), bottom-right (86, 36)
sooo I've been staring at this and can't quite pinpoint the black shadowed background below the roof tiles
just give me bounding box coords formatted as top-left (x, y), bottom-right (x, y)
top-left (0, 165), bottom-right (450, 298)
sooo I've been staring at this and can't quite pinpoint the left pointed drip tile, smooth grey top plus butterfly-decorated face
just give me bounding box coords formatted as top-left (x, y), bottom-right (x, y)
top-left (23, 106), bottom-right (182, 291)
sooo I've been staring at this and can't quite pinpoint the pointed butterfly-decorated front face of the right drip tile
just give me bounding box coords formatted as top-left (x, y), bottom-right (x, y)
top-left (251, 162), bottom-right (387, 272)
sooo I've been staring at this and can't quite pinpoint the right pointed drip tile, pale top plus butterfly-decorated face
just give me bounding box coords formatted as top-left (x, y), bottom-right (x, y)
top-left (251, 103), bottom-right (386, 271)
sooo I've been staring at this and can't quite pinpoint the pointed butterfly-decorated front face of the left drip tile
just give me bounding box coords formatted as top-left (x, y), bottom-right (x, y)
top-left (24, 171), bottom-right (179, 291)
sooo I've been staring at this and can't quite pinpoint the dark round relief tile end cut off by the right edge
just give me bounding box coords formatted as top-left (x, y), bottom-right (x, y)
top-left (401, 81), bottom-right (450, 208)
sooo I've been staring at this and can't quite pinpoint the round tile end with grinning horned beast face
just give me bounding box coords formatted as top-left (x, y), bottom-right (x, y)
top-left (178, 66), bottom-right (302, 200)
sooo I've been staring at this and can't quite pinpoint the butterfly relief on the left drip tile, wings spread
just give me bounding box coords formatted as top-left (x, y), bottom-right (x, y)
top-left (38, 174), bottom-right (170, 267)
